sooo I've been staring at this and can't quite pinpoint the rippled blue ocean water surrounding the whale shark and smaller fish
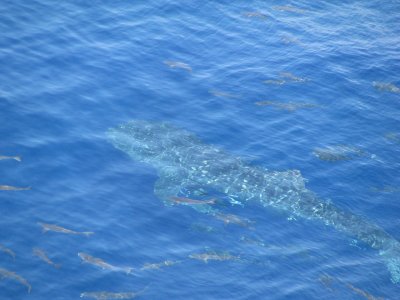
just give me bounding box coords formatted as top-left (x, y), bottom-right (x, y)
top-left (0, 0), bottom-right (400, 299)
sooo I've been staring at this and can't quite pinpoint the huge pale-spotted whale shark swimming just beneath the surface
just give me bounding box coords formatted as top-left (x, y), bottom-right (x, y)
top-left (106, 120), bottom-right (400, 283)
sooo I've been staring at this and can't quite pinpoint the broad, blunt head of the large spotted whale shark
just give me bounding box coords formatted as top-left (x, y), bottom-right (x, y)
top-left (106, 120), bottom-right (199, 162)
